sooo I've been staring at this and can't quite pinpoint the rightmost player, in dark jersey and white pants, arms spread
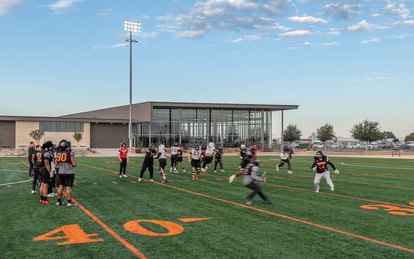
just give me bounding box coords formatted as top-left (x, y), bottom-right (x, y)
top-left (311, 151), bottom-right (339, 192)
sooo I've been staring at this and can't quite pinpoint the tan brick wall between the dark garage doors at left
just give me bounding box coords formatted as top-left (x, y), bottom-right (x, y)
top-left (16, 121), bottom-right (91, 148)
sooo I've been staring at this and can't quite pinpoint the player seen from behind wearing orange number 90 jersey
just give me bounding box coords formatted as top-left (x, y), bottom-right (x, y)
top-left (55, 139), bottom-right (77, 207)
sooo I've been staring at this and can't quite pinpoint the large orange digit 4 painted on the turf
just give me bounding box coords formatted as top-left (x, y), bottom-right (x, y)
top-left (33, 224), bottom-right (104, 245)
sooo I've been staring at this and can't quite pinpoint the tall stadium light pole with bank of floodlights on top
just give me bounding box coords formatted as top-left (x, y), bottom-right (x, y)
top-left (124, 20), bottom-right (141, 149)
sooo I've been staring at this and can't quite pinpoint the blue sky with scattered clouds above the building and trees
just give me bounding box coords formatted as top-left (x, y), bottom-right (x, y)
top-left (0, 0), bottom-right (414, 140)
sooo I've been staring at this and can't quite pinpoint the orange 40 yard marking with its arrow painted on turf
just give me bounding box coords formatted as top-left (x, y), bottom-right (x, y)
top-left (33, 218), bottom-right (211, 245)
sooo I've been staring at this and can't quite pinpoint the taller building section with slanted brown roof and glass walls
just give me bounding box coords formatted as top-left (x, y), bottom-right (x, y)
top-left (58, 102), bottom-right (298, 150)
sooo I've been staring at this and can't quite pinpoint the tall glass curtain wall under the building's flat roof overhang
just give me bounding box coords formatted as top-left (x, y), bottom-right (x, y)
top-left (134, 107), bottom-right (272, 148)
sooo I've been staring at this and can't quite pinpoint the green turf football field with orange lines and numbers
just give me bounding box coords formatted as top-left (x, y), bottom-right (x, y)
top-left (0, 157), bottom-right (414, 259)
